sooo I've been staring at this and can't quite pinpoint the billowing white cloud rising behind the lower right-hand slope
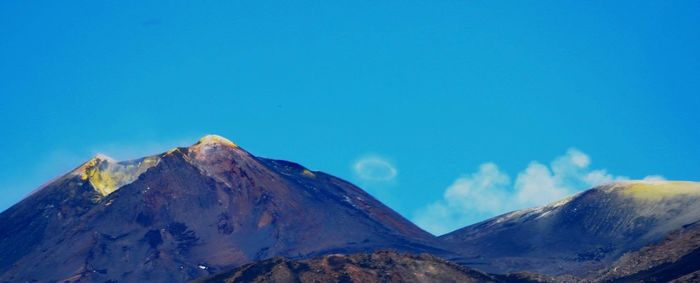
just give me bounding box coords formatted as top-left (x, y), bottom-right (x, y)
top-left (414, 149), bottom-right (663, 235)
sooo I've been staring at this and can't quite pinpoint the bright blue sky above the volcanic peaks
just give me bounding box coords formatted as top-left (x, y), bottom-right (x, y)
top-left (0, 1), bottom-right (700, 233)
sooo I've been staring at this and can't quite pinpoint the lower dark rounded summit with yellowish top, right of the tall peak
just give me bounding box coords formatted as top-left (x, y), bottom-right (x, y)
top-left (441, 181), bottom-right (700, 276)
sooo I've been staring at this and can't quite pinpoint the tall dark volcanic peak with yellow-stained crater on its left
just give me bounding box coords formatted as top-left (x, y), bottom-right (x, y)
top-left (0, 135), bottom-right (444, 282)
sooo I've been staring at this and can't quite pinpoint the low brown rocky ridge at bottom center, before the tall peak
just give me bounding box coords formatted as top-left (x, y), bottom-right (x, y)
top-left (198, 252), bottom-right (504, 283)
